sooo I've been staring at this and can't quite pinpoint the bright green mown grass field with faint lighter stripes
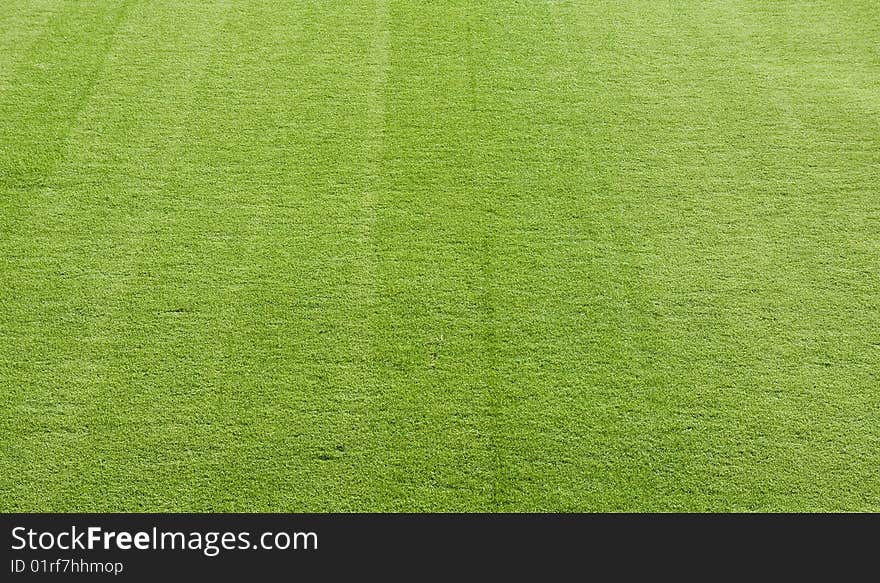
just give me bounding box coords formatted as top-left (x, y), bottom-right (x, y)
top-left (0, 0), bottom-right (880, 512)
